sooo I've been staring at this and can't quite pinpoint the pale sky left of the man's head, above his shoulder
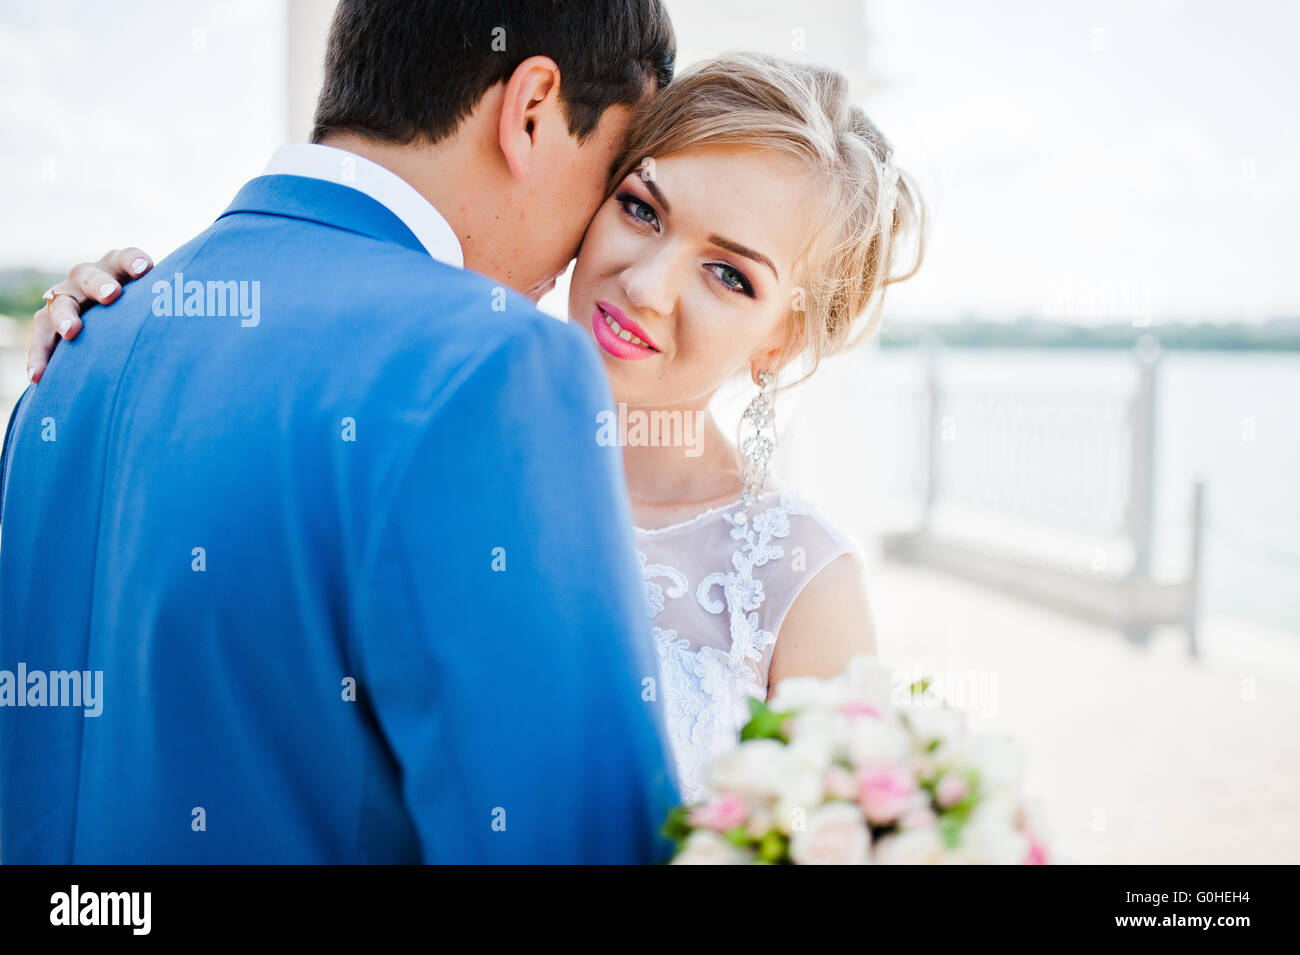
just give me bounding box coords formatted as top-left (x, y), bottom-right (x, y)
top-left (0, 0), bottom-right (286, 270)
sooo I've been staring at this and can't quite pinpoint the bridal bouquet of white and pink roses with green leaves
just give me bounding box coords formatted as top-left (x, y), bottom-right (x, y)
top-left (664, 656), bottom-right (1048, 865)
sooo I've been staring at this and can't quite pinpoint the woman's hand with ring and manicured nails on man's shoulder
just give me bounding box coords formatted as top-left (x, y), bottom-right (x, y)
top-left (27, 248), bottom-right (153, 385)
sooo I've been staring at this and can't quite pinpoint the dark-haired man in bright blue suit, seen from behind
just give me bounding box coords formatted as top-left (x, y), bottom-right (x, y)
top-left (0, 0), bottom-right (676, 863)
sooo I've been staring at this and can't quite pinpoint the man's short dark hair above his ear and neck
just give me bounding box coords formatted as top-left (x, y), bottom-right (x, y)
top-left (312, 0), bottom-right (676, 143)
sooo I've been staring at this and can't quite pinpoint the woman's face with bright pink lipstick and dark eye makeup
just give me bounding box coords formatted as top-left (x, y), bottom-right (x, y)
top-left (569, 147), bottom-right (811, 407)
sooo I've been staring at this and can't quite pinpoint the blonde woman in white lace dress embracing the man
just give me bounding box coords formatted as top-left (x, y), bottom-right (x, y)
top-left (34, 55), bottom-right (922, 802)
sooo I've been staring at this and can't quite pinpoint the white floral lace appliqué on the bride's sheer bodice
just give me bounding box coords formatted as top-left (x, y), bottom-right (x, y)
top-left (637, 494), bottom-right (803, 803)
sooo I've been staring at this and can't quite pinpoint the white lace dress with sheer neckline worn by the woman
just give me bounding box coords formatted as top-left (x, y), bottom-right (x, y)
top-left (636, 490), bottom-right (858, 803)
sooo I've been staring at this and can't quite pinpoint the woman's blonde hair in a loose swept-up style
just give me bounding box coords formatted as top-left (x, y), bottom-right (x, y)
top-left (612, 53), bottom-right (924, 378)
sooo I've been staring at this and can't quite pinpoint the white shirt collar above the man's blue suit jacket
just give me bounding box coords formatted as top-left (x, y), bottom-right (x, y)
top-left (263, 143), bottom-right (465, 269)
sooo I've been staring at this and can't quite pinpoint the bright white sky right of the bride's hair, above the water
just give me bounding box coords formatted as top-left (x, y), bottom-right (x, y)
top-left (867, 0), bottom-right (1300, 321)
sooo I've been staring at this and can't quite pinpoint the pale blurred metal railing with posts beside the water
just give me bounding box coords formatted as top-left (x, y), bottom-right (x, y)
top-left (884, 342), bottom-right (1204, 656)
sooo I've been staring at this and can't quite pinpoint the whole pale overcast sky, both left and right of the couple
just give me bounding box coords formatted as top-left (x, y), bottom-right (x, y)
top-left (0, 0), bottom-right (1300, 322)
